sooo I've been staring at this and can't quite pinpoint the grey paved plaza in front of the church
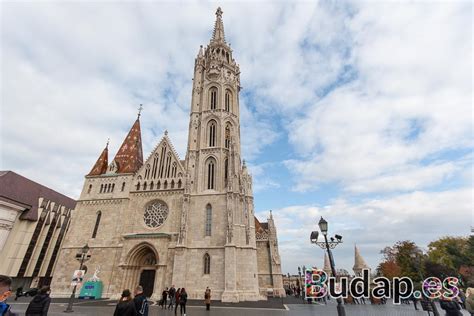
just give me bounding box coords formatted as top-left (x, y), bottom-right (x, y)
top-left (9, 298), bottom-right (469, 316)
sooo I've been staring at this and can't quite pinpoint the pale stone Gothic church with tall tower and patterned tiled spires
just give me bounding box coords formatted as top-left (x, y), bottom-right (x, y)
top-left (51, 8), bottom-right (285, 302)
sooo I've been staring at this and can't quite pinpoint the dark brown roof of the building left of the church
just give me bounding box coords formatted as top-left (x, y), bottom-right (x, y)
top-left (0, 170), bottom-right (76, 221)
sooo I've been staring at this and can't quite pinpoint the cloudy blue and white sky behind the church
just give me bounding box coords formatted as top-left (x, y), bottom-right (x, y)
top-left (0, 1), bottom-right (474, 273)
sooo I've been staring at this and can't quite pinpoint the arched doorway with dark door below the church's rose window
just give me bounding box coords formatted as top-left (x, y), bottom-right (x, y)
top-left (127, 243), bottom-right (158, 297)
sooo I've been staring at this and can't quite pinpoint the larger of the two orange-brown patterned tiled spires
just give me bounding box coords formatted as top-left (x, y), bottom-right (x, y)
top-left (114, 114), bottom-right (143, 173)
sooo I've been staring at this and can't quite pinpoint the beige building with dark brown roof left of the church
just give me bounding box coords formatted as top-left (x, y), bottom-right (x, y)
top-left (0, 171), bottom-right (76, 289)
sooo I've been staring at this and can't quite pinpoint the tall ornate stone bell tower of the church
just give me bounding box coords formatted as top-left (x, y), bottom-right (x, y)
top-left (173, 8), bottom-right (259, 302)
